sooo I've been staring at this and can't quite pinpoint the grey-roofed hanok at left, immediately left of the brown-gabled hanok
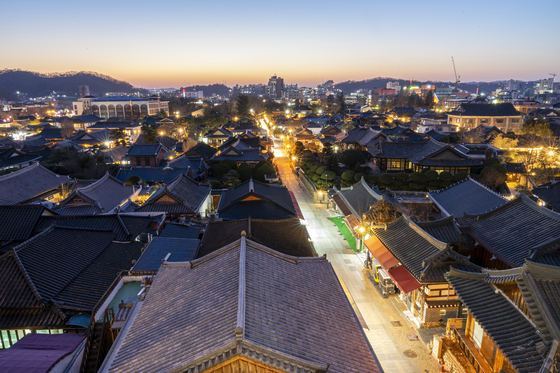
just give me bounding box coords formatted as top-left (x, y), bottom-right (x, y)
top-left (53, 172), bottom-right (142, 215)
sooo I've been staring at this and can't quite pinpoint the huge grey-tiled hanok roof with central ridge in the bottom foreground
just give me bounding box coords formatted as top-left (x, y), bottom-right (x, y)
top-left (100, 234), bottom-right (382, 373)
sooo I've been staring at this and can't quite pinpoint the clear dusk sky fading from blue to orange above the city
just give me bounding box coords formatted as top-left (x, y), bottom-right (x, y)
top-left (0, 0), bottom-right (560, 88)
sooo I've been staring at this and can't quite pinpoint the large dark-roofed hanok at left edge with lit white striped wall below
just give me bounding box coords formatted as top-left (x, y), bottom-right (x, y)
top-left (0, 225), bottom-right (148, 348)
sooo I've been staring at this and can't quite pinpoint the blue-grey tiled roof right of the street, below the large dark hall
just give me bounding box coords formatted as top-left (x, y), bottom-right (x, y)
top-left (429, 177), bottom-right (507, 218)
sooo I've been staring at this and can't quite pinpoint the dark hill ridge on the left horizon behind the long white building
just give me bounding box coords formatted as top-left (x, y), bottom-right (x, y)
top-left (0, 69), bottom-right (144, 99)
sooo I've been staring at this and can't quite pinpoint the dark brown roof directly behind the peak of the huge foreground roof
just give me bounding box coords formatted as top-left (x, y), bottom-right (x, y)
top-left (197, 218), bottom-right (316, 258)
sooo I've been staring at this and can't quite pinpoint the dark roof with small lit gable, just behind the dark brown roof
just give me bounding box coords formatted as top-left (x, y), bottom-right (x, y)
top-left (218, 179), bottom-right (297, 220)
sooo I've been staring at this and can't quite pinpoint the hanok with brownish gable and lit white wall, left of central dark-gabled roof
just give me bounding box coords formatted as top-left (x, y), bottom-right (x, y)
top-left (136, 173), bottom-right (212, 220)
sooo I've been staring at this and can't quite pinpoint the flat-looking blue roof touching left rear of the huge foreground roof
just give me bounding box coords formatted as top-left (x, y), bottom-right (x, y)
top-left (133, 237), bottom-right (200, 271)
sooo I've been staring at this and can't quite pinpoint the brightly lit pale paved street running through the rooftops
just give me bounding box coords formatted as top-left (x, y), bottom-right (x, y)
top-left (275, 144), bottom-right (440, 373)
